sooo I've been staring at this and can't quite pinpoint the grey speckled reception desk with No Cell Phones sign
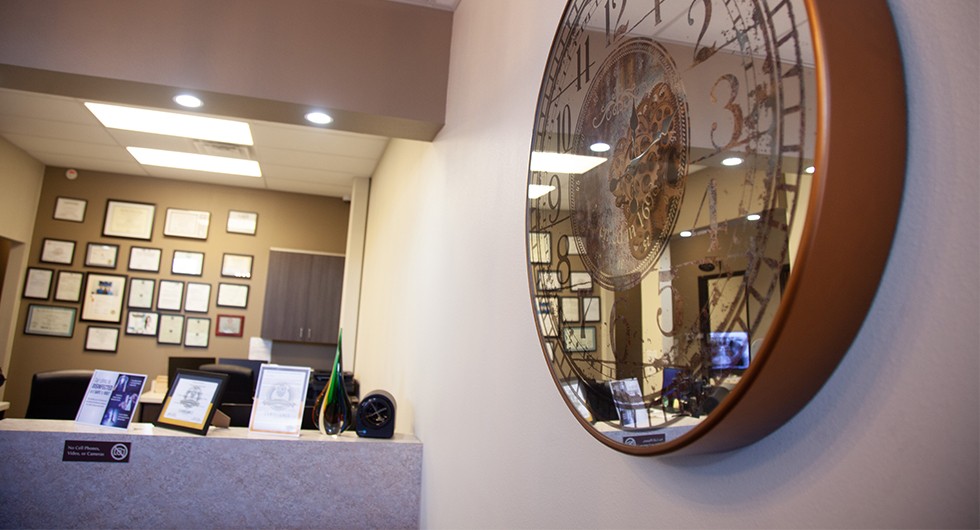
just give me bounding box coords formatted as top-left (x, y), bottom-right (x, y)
top-left (0, 418), bottom-right (422, 528)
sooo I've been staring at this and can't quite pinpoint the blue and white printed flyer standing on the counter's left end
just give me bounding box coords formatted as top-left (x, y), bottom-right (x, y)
top-left (75, 370), bottom-right (146, 429)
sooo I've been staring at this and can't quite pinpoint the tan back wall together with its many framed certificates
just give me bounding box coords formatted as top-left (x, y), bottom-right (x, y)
top-left (6, 168), bottom-right (349, 416)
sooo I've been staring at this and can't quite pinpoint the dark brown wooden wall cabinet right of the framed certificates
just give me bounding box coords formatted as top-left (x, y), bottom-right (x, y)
top-left (262, 250), bottom-right (344, 344)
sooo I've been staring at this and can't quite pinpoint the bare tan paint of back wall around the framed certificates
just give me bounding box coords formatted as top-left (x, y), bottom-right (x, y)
top-left (6, 168), bottom-right (349, 417)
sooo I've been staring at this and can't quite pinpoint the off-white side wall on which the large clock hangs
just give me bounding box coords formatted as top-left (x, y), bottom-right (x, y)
top-left (357, 0), bottom-right (980, 528)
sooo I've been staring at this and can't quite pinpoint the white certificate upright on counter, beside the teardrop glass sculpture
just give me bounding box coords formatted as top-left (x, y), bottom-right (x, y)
top-left (248, 364), bottom-right (310, 436)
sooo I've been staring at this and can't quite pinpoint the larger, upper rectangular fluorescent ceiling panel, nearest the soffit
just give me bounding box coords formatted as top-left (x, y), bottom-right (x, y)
top-left (85, 102), bottom-right (252, 145)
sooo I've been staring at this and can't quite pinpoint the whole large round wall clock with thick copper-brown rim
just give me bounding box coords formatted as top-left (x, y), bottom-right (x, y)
top-left (527, 0), bottom-right (905, 455)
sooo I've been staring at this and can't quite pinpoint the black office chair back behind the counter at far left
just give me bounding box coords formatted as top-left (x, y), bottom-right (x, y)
top-left (24, 370), bottom-right (94, 420)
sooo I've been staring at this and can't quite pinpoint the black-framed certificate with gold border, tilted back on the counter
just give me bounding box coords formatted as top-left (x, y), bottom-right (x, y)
top-left (153, 368), bottom-right (228, 436)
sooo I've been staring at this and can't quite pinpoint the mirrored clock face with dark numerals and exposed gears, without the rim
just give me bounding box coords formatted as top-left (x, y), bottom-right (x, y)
top-left (527, 0), bottom-right (814, 453)
